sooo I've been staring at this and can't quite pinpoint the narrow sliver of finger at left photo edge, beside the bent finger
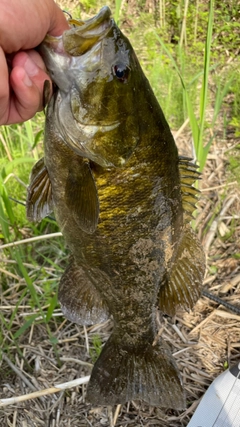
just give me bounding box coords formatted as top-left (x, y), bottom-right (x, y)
top-left (0, 47), bottom-right (9, 125)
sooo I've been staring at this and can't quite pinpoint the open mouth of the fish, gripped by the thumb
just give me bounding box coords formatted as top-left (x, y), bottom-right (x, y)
top-left (62, 6), bottom-right (113, 56)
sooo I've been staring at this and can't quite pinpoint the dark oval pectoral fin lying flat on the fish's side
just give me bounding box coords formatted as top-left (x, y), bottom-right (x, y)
top-left (66, 160), bottom-right (99, 234)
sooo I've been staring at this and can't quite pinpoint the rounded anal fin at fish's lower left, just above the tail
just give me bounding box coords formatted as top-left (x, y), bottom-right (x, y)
top-left (58, 260), bottom-right (109, 325)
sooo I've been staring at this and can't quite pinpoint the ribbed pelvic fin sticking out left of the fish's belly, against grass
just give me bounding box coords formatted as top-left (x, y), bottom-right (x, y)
top-left (26, 157), bottom-right (53, 221)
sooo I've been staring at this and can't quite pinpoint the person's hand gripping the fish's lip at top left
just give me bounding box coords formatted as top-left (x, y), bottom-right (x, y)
top-left (0, 0), bottom-right (69, 125)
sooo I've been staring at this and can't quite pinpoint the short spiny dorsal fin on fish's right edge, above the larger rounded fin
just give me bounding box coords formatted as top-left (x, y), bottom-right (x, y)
top-left (178, 156), bottom-right (200, 222)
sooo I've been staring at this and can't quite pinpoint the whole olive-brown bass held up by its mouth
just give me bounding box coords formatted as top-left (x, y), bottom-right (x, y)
top-left (27, 6), bottom-right (205, 410)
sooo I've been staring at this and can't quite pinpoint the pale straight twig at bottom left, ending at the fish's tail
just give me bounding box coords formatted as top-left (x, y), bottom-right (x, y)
top-left (0, 375), bottom-right (90, 407)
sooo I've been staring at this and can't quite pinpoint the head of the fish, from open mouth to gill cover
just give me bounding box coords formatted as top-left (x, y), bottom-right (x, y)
top-left (40, 6), bottom-right (145, 167)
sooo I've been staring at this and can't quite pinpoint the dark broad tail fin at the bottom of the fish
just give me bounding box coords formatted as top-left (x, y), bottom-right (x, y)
top-left (86, 334), bottom-right (185, 409)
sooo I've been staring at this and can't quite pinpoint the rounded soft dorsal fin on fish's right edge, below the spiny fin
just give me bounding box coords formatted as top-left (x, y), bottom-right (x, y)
top-left (158, 226), bottom-right (205, 316)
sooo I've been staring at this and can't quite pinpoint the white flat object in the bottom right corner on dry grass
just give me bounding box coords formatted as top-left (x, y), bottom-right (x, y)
top-left (187, 363), bottom-right (240, 427)
